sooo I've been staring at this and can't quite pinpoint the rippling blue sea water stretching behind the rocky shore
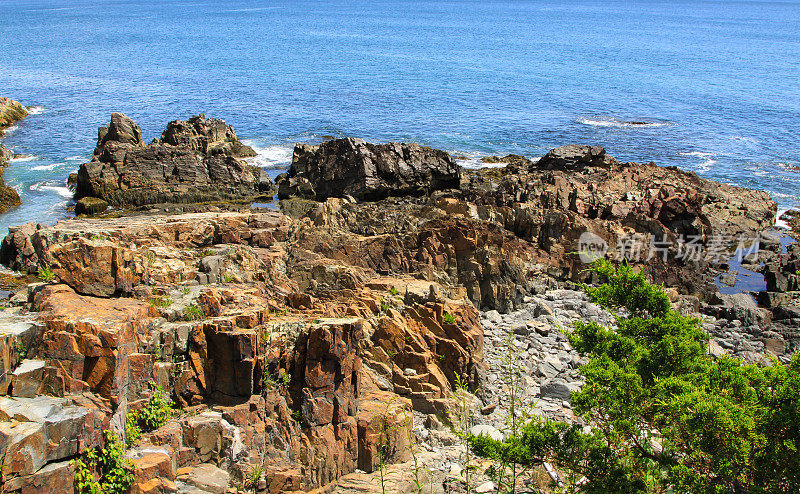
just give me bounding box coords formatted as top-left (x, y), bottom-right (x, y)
top-left (0, 0), bottom-right (800, 231)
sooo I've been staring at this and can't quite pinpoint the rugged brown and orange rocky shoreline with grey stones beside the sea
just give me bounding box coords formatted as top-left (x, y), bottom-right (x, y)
top-left (0, 110), bottom-right (800, 494)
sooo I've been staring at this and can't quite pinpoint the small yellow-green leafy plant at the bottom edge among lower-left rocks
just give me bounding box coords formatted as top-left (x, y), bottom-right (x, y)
top-left (72, 431), bottom-right (133, 494)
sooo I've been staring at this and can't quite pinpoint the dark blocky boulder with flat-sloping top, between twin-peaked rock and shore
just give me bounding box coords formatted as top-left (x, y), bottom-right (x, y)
top-left (286, 138), bottom-right (461, 201)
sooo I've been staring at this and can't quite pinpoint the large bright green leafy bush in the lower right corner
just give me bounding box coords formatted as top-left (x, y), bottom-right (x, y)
top-left (470, 260), bottom-right (800, 493)
